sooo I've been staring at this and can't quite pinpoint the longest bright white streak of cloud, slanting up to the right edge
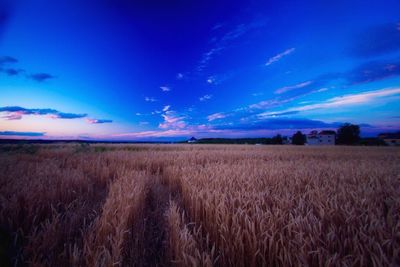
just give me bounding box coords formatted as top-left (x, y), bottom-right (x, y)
top-left (258, 88), bottom-right (400, 117)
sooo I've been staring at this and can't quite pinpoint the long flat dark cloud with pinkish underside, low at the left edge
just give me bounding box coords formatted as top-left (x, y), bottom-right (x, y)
top-left (0, 106), bottom-right (87, 120)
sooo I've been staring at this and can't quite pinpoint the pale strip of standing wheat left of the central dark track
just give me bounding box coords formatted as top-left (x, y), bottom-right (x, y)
top-left (83, 171), bottom-right (147, 266)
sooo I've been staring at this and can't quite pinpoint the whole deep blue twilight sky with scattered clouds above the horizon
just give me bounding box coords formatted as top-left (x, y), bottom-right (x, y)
top-left (0, 0), bottom-right (400, 140)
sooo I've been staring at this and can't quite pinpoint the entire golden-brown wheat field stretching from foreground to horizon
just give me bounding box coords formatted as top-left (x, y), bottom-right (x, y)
top-left (0, 144), bottom-right (400, 266)
